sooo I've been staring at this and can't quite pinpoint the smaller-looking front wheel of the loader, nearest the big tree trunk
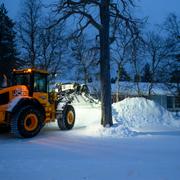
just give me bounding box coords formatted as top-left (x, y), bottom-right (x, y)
top-left (57, 105), bottom-right (76, 130)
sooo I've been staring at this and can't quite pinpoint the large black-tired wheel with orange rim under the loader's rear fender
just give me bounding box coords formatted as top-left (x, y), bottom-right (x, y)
top-left (11, 106), bottom-right (44, 138)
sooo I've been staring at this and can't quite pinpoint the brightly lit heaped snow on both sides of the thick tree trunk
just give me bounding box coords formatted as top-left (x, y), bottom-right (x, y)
top-left (75, 98), bottom-right (180, 137)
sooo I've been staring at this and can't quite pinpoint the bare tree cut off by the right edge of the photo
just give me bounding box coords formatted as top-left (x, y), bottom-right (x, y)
top-left (161, 13), bottom-right (180, 94)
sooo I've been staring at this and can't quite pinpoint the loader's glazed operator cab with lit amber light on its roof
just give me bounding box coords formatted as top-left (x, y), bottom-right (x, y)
top-left (13, 69), bottom-right (48, 96)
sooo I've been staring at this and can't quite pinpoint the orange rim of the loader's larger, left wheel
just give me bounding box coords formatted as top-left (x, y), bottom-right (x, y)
top-left (24, 114), bottom-right (38, 131)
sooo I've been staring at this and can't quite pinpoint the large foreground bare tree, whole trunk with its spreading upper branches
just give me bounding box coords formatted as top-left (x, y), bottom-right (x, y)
top-left (50, 0), bottom-right (139, 127)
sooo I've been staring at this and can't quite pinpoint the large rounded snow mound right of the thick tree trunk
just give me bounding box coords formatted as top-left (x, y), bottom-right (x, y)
top-left (113, 98), bottom-right (175, 129)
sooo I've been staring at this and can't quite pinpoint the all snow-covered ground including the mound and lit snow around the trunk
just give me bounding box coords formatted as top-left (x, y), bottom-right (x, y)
top-left (0, 98), bottom-right (180, 180)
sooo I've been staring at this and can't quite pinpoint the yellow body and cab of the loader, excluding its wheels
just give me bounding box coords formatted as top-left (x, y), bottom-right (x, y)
top-left (0, 69), bottom-right (56, 125)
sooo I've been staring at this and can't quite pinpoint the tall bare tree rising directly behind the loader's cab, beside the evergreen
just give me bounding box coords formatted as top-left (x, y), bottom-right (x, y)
top-left (17, 0), bottom-right (42, 67)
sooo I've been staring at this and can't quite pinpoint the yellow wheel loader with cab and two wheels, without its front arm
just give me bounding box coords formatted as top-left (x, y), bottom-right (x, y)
top-left (0, 68), bottom-right (75, 138)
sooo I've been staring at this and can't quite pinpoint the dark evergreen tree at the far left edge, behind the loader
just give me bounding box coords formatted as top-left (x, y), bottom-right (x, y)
top-left (0, 4), bottom-right (17, 82)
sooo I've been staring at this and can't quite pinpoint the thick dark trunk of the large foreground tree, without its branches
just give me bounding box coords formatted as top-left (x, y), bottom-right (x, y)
top-left (99, 0), bottom-right (113, 127)
